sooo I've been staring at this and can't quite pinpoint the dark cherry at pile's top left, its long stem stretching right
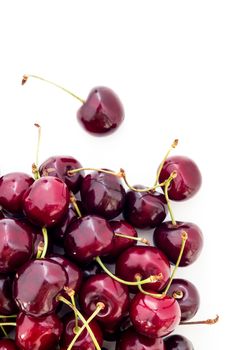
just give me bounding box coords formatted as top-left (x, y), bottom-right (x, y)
top-left (39, 156), bottom-right (84, 193)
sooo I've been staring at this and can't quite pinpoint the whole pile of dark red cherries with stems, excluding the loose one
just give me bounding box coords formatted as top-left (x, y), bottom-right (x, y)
top-left (0, 77), bottom-right (217, 350)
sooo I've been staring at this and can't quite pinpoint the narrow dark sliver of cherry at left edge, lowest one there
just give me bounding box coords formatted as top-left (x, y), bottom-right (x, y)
top-left (0, 275), bottom-right (17, 314)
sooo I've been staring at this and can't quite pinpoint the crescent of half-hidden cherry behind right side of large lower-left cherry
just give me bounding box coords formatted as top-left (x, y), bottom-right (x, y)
top-left (49, 255), bottom-right (82, 292)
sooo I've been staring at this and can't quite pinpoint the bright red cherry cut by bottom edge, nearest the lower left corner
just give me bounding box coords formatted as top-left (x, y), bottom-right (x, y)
top-left (15, 312), bottom-right (63, 350)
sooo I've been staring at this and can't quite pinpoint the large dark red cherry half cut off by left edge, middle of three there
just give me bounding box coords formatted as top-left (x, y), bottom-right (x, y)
top-left (0, 219), bottom-right (33, 273)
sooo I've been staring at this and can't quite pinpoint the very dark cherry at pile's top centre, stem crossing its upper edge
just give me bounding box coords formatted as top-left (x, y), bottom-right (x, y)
top-left (81, 171), bottom-right (125, 220)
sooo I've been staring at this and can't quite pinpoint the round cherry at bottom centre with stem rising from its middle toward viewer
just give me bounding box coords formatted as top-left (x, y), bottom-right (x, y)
top-left (79, 274), bottom-right (129, 326)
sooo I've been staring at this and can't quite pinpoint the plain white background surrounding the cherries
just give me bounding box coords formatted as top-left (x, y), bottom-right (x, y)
top-left (0, 0), bottom-right (233, 350)
